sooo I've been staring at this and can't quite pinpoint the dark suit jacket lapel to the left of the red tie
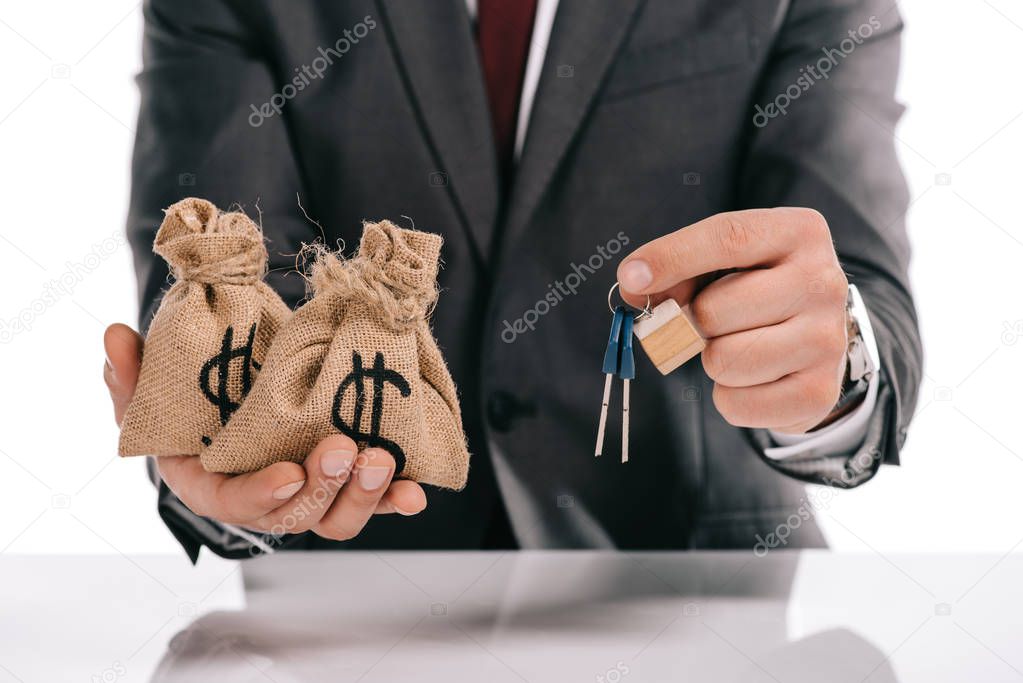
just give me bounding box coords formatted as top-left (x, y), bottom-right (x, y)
top-left (377, 0), bottom-right (498, 263)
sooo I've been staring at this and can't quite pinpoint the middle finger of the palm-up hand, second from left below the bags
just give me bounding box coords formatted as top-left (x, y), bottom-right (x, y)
top-left (253, 435), bottom-right (358, 534)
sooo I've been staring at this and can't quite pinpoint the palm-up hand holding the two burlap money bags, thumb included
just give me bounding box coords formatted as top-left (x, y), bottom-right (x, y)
top-left (103, 324), bottom-right (427, 541)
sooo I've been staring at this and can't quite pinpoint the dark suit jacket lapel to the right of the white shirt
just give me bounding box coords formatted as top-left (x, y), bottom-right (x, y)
top-left (502, 0), bottom-right (642, 254)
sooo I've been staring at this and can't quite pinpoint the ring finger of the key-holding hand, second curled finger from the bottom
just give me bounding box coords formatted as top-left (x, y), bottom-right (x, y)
top-left (701, 315), bottom-right (846, 388)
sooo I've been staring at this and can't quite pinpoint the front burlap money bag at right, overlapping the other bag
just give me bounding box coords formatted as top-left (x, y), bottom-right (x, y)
top-left (202, 221), bottom-right (469, 489)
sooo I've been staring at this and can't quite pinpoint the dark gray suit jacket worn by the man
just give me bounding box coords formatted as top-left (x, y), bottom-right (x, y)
top-left (128, 0), bottom-right (921, 556)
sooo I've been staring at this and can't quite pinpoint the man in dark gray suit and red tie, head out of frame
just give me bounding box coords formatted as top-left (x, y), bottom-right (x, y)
top-left (104, 0), bottom-right (922, 559)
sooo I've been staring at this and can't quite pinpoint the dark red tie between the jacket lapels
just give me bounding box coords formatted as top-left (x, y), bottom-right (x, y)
top-left (477, 0), bottom-right (536, 186)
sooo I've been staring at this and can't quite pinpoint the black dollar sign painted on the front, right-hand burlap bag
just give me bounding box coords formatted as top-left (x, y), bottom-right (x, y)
top-left (330, 351), bottom-right (411, 472)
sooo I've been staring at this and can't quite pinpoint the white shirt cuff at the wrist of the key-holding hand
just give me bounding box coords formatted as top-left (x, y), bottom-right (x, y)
top-left (764, 285), bottom-right (881, 460)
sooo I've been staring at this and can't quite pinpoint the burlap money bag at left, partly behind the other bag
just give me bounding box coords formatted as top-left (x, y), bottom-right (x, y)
top-left (119, 198), bottom-right (292, 455)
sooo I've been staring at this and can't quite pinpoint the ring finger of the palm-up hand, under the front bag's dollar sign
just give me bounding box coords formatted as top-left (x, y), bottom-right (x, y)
top-left (313, 448), bottom-right (395, 541)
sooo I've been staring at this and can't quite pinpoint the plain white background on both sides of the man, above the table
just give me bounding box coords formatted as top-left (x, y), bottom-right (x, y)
top-left (0, 0), bottom-right (1023, 554)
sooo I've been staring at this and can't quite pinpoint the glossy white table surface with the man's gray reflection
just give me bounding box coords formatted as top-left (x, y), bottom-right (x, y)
top-left (0, 551), bottom-right (1023, 683)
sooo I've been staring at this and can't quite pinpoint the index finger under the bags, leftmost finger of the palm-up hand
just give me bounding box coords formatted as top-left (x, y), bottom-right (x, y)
top-left (157, 455), bottom-right (306, 525)
